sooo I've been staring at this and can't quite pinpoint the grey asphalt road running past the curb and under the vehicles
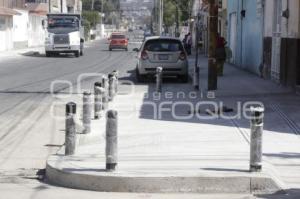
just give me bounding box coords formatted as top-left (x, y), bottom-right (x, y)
top-left (0, 37), bottom-right (296, 199)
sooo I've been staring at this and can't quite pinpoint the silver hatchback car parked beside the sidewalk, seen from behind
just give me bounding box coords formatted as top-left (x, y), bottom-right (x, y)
top-left (134, 36), bottom-right (188, 82)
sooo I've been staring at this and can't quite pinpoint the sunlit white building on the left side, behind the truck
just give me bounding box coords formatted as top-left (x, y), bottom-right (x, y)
top-left (0, 0), bottom-right (82, 51)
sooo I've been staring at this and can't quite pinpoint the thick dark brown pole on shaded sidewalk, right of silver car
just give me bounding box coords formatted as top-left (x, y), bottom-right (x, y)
top-left (207, 0), bottom-right (218, 91)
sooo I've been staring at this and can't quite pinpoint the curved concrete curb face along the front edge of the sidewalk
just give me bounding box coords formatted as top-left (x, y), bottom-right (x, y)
top-left (46, 155), bottom-right (282, 194)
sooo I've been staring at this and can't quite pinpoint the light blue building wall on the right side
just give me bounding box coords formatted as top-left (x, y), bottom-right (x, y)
top-left (227, 0), bottom-right (264, 75)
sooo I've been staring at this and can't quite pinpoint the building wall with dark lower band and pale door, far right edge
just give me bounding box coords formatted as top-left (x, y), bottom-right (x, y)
top-left (264, 0), bottom-right (300, 88)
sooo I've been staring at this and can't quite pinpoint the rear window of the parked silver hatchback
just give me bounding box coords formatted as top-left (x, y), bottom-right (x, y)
top-left (144, 39), bottom-right (183, 52)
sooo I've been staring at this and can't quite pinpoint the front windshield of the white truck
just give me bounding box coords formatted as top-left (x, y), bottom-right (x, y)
top-left (48, 17), bottom-right (79, 28)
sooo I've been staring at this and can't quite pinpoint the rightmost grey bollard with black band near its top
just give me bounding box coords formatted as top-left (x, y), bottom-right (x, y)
top-left (250, 107), bottom-right (264, 172)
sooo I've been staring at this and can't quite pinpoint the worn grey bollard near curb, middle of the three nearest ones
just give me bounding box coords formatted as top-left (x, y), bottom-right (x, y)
top-left (105, 110), bottom-right (118, 171)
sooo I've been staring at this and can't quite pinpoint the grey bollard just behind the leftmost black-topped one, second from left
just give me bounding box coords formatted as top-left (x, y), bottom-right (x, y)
top-left (82, 92), bottom-right (92, 134)
